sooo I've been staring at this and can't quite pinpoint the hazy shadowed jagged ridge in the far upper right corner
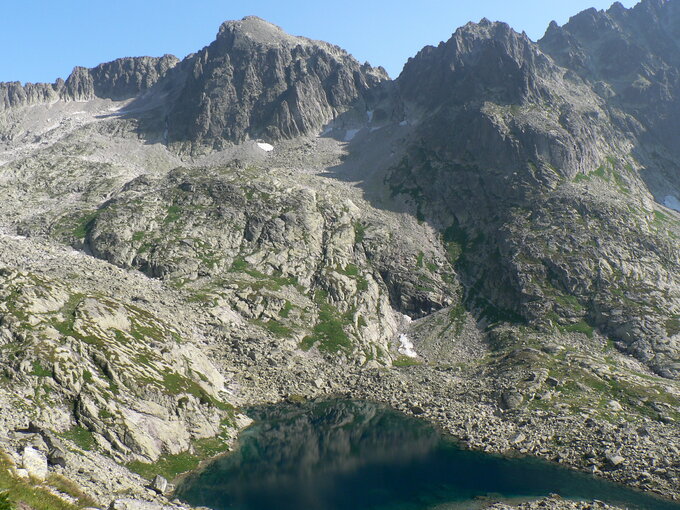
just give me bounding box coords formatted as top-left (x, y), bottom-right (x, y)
top-left (539, 0), bottom-right (680, 195)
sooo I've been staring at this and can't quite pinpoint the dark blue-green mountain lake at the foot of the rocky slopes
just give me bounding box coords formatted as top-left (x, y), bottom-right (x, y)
top-left (177, 401), bottom-right (680, 510)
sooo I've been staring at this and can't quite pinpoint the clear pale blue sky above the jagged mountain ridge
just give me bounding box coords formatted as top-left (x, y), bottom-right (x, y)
top-left (0, 0), bottom-right (637, 82)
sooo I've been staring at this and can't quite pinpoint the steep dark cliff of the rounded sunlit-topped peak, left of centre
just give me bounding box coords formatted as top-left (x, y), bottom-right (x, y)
top-left (158, 17), bottom-right (387, 146)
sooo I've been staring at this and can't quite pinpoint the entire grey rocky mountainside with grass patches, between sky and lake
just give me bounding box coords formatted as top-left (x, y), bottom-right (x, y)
top-left (0, 5), bottom-right (680, 510)
